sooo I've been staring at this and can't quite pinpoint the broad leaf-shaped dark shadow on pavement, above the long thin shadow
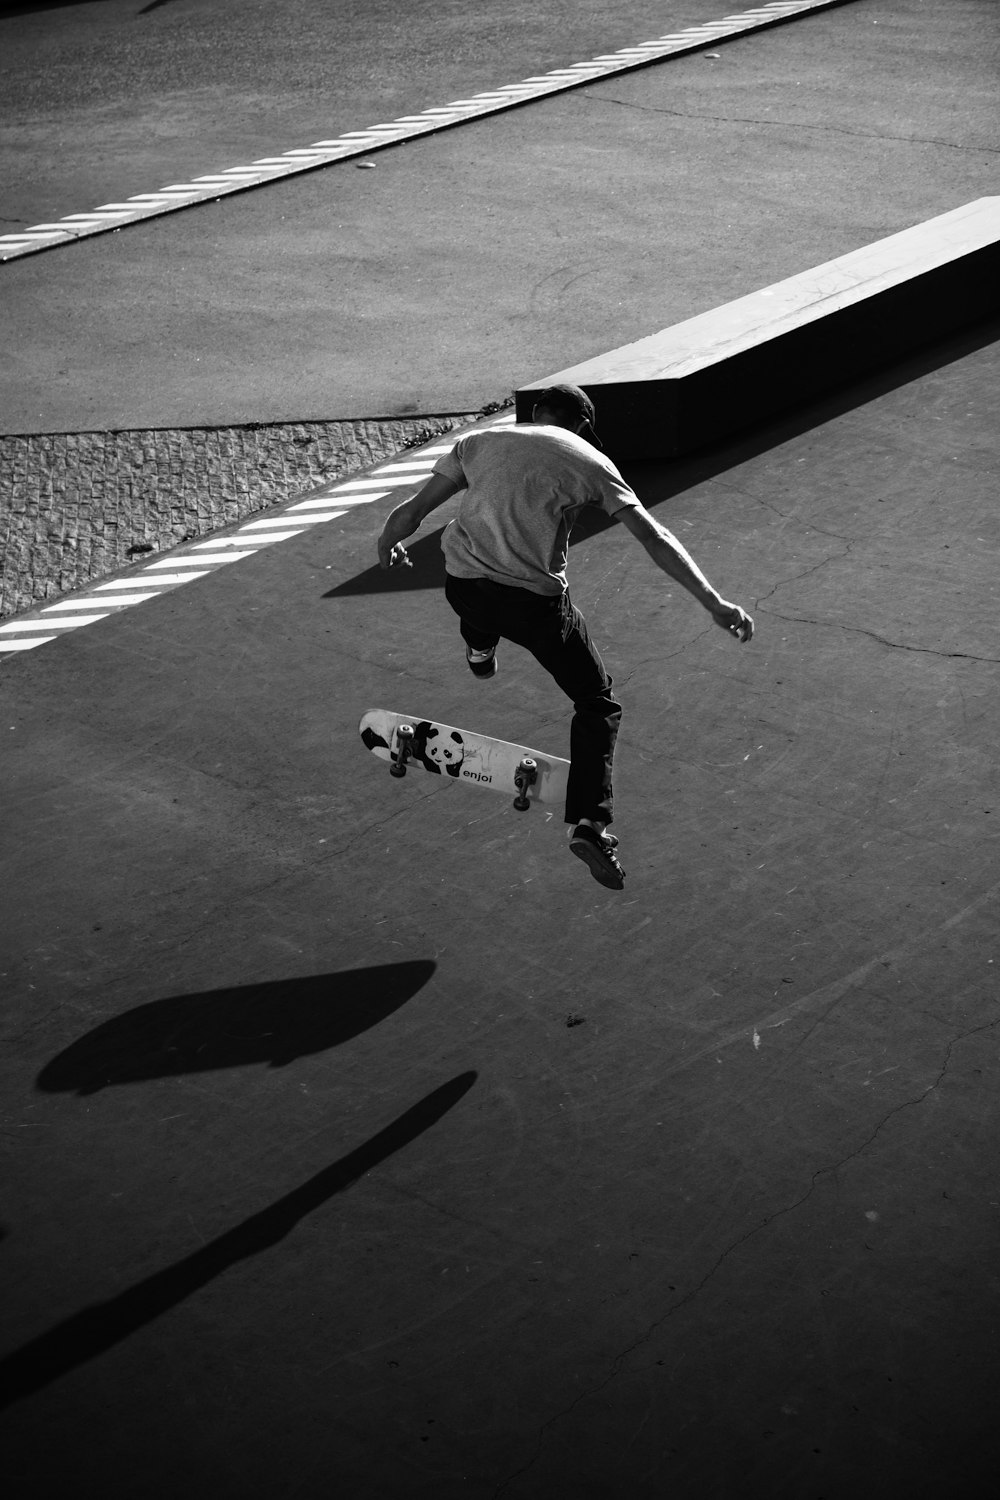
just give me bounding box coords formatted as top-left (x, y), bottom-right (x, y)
top-left (36, 959), bottom-right (435, 1095)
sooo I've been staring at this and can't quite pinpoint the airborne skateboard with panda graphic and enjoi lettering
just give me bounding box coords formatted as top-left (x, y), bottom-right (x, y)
top-left (358, 708), bottom-right (570, 813)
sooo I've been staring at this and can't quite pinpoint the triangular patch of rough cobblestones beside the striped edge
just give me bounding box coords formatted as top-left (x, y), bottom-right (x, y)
top-left (0, 413), bottom-right (480, 618)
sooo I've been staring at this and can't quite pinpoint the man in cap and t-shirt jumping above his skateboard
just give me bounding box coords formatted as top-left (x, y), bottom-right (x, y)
top-left (378, 386), bottom-right (754, 891)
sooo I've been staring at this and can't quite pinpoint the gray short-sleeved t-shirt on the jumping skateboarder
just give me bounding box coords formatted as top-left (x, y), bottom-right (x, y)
top-left (435, 423), bottom-right (639, 594)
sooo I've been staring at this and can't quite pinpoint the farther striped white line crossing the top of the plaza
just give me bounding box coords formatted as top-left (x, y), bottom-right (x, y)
top-left (0, 0), bottom-right (849, 261)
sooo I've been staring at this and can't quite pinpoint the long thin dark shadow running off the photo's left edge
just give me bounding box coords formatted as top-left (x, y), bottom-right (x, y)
top-left (0, 1071), bottom-right (477, 1409)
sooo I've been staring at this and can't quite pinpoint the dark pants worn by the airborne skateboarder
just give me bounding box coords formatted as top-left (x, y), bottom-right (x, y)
top-left (445, 573), bottom-right (622, 824)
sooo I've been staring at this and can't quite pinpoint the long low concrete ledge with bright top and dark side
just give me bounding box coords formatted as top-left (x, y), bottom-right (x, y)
top-left (517, 198), bottom-right (1000, 459)
